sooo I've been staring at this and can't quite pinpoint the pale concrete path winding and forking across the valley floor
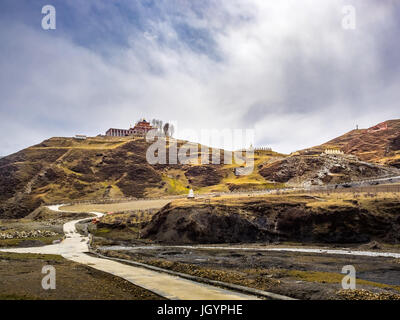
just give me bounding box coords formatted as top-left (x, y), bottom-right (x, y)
top-left (0, 205), bottom-right (258, 300)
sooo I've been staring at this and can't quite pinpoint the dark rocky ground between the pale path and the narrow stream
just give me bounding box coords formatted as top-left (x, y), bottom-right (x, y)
top-left (96, 246), bottom-right (400, 300)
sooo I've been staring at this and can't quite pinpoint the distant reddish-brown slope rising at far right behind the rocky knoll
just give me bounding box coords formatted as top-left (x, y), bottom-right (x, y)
top-left (300, 119), bottom-right (400, 168)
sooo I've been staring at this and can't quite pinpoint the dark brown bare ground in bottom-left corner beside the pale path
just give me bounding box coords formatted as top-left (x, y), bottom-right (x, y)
top-left (0, 253), bottom-right (161, 300)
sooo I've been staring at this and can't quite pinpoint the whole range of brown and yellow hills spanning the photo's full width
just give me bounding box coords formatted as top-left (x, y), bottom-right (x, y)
top-left (0, 120), bottom-right (400, 218)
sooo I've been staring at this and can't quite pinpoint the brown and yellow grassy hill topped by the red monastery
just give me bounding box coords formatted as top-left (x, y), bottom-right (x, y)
top-left (0, 137), bottom-right (279, 218)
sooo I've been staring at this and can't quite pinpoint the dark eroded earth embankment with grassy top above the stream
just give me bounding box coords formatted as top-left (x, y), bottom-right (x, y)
top-left (142, 199), bottom-right (400, 244)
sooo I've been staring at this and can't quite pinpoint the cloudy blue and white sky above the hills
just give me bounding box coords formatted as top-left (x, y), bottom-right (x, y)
top-left (0, 0), bottom-right (400, 156)
